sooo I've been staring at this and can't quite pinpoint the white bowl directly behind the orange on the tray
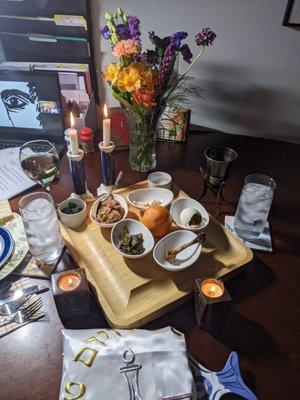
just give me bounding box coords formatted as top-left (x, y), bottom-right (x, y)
top-left (127, 188), bottom-right (174, 210)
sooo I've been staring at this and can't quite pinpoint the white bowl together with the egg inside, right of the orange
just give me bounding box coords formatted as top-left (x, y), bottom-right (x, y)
top-left (170, 198), bottom-right (209, 231)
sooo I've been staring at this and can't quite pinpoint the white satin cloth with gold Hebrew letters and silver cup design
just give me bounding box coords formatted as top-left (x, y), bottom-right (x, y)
top-left (59, 327), bottom-right (196, 400)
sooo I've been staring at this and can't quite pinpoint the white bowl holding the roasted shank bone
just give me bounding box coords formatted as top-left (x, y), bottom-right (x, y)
top-left (153, 230), bottom-right (202, 271)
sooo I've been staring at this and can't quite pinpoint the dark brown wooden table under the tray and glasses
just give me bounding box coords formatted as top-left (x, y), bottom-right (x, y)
top-left (0, 132), bottom-right (300, 400)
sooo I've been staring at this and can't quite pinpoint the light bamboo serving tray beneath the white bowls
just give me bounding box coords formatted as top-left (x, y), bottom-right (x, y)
top-left (61, 181), bottom-right (253, 328)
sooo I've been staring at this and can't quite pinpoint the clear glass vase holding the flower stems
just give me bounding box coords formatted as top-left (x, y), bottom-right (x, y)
top-left (126, 109), bottom-right (160, 172)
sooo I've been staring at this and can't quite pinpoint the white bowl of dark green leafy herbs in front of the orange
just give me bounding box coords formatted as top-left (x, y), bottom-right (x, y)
top-left (111, 218), bottom-right (154, 258)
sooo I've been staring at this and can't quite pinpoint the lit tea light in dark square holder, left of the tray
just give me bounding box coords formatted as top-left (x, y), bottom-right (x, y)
top-left (51, 269), bottom-right (89, 318)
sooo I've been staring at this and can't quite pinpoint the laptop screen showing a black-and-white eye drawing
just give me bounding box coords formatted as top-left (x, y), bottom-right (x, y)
top-left (0, 70), bottom-right (64, 143)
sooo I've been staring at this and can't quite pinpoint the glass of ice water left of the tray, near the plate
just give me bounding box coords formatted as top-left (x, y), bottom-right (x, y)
top-left (19, 192), bottom-right (63, 264)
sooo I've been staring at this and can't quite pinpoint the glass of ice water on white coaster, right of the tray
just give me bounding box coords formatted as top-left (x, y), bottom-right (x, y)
top-left (234, 174), bottom-right (276, 241)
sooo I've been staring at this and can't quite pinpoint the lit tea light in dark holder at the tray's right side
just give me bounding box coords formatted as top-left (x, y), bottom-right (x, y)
top-left (195, 278), bottom-right (231, 333)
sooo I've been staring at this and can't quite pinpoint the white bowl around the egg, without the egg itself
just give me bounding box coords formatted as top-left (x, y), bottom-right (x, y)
top-left (170, 197), bottom-right (209, 231)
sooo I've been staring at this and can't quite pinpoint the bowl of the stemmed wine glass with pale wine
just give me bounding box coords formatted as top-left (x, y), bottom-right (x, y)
top-left (19, 140), bottom-right (59, 192)
